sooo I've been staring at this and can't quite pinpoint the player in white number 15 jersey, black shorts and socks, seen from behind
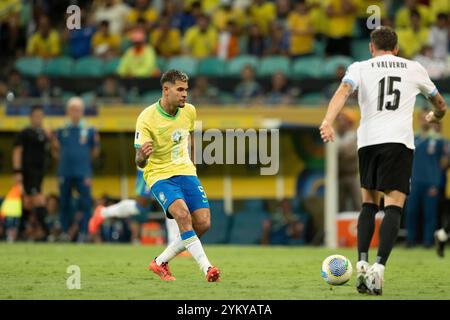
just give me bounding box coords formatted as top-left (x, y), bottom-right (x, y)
top-left (320, 26), bottom-right (447, 295)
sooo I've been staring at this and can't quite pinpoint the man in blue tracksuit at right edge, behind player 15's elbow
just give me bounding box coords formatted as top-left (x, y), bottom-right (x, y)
top-left (406, 111), bottom-right (448, 247)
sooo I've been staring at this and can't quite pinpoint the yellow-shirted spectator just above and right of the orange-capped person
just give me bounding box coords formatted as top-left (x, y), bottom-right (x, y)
top-left (150, 16), bottom-right (181, 58)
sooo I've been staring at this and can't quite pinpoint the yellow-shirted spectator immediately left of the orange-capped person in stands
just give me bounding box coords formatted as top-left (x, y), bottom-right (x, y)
top-left (91, 20), bottom-right (120, 59)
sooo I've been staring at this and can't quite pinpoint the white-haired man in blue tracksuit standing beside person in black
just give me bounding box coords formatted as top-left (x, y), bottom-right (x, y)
top-left (52, 97), bottom-right (100, 241)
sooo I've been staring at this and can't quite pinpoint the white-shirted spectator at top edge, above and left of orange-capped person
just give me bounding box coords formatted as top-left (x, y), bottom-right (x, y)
top-left (93, 0), bottom-right (130, 34)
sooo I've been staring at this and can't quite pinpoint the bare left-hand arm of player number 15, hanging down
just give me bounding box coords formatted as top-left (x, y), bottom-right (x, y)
top-left (319, 82), bottom-right (353, 142)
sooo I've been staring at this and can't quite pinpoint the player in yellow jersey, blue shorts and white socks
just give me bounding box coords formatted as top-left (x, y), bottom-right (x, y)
top-left (134, 70), bottom-right (220, 282)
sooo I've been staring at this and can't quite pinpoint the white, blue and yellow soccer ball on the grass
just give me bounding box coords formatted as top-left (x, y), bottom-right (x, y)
top-left (322, 254), bottom-right (353, 286)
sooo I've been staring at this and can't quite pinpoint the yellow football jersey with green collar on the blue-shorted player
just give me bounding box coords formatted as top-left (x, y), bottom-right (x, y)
top-left (134, 101), bottom-right (197, 187)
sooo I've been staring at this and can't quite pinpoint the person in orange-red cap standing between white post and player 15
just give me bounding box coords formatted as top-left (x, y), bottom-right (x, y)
top-left (336, 109), bottom-right (361, 212)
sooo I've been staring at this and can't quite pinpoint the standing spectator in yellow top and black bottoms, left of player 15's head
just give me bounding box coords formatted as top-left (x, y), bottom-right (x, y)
top-left (325, 0), bottom-right (357, 56)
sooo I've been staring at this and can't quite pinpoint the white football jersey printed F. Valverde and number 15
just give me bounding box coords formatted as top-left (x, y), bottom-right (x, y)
top-left (342, 54), bottom-right (437, 149)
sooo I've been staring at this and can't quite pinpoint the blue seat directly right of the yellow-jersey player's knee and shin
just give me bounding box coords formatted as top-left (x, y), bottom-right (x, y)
top-left (202, 200), bottom-right (230, 244)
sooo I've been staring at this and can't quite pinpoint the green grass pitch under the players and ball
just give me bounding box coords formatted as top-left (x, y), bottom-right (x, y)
top-left (0, 243), bottom-right (450, 300)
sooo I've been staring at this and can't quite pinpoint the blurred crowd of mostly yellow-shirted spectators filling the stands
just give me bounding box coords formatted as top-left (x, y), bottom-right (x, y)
top-left (0, 0), bottom-right (450, 106)
